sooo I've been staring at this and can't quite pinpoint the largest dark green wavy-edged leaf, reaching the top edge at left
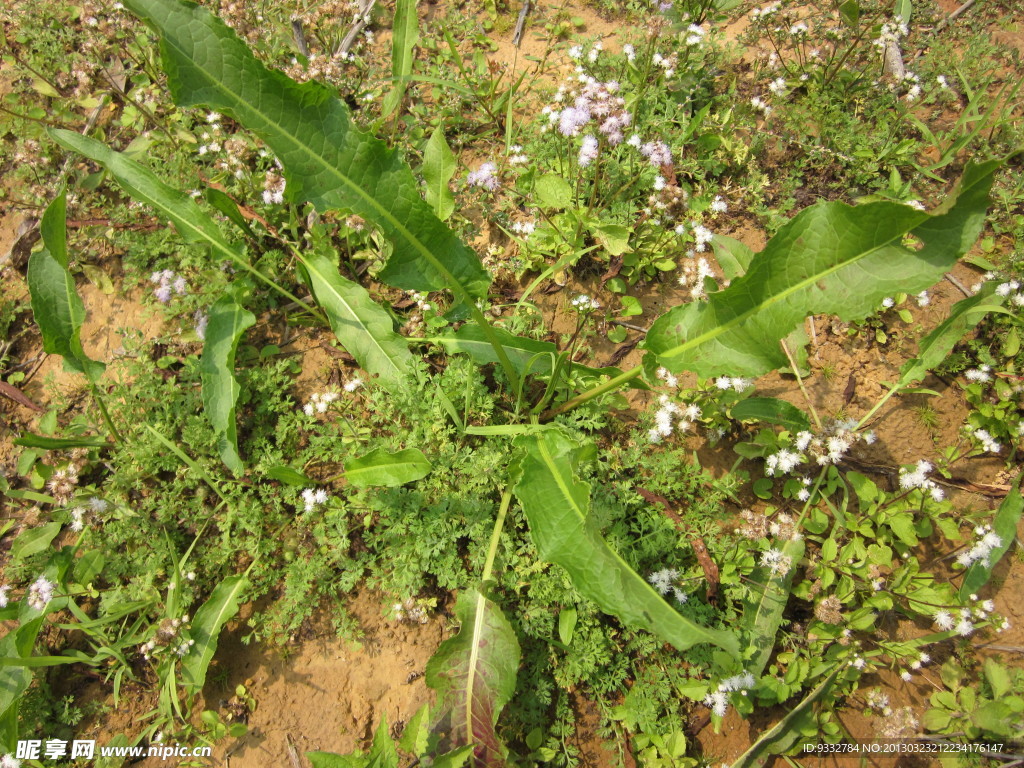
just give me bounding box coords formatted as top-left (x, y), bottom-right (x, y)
top-left (119, 0), bottom-right (489, 300)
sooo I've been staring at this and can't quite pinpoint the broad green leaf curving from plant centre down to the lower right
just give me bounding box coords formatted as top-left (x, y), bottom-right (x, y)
top-left (515, 430), bottom-right (739, 657)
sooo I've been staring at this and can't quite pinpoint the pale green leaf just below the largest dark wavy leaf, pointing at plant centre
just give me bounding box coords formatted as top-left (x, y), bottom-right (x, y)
top-left (302, 254), bottom-right (413, 389)
